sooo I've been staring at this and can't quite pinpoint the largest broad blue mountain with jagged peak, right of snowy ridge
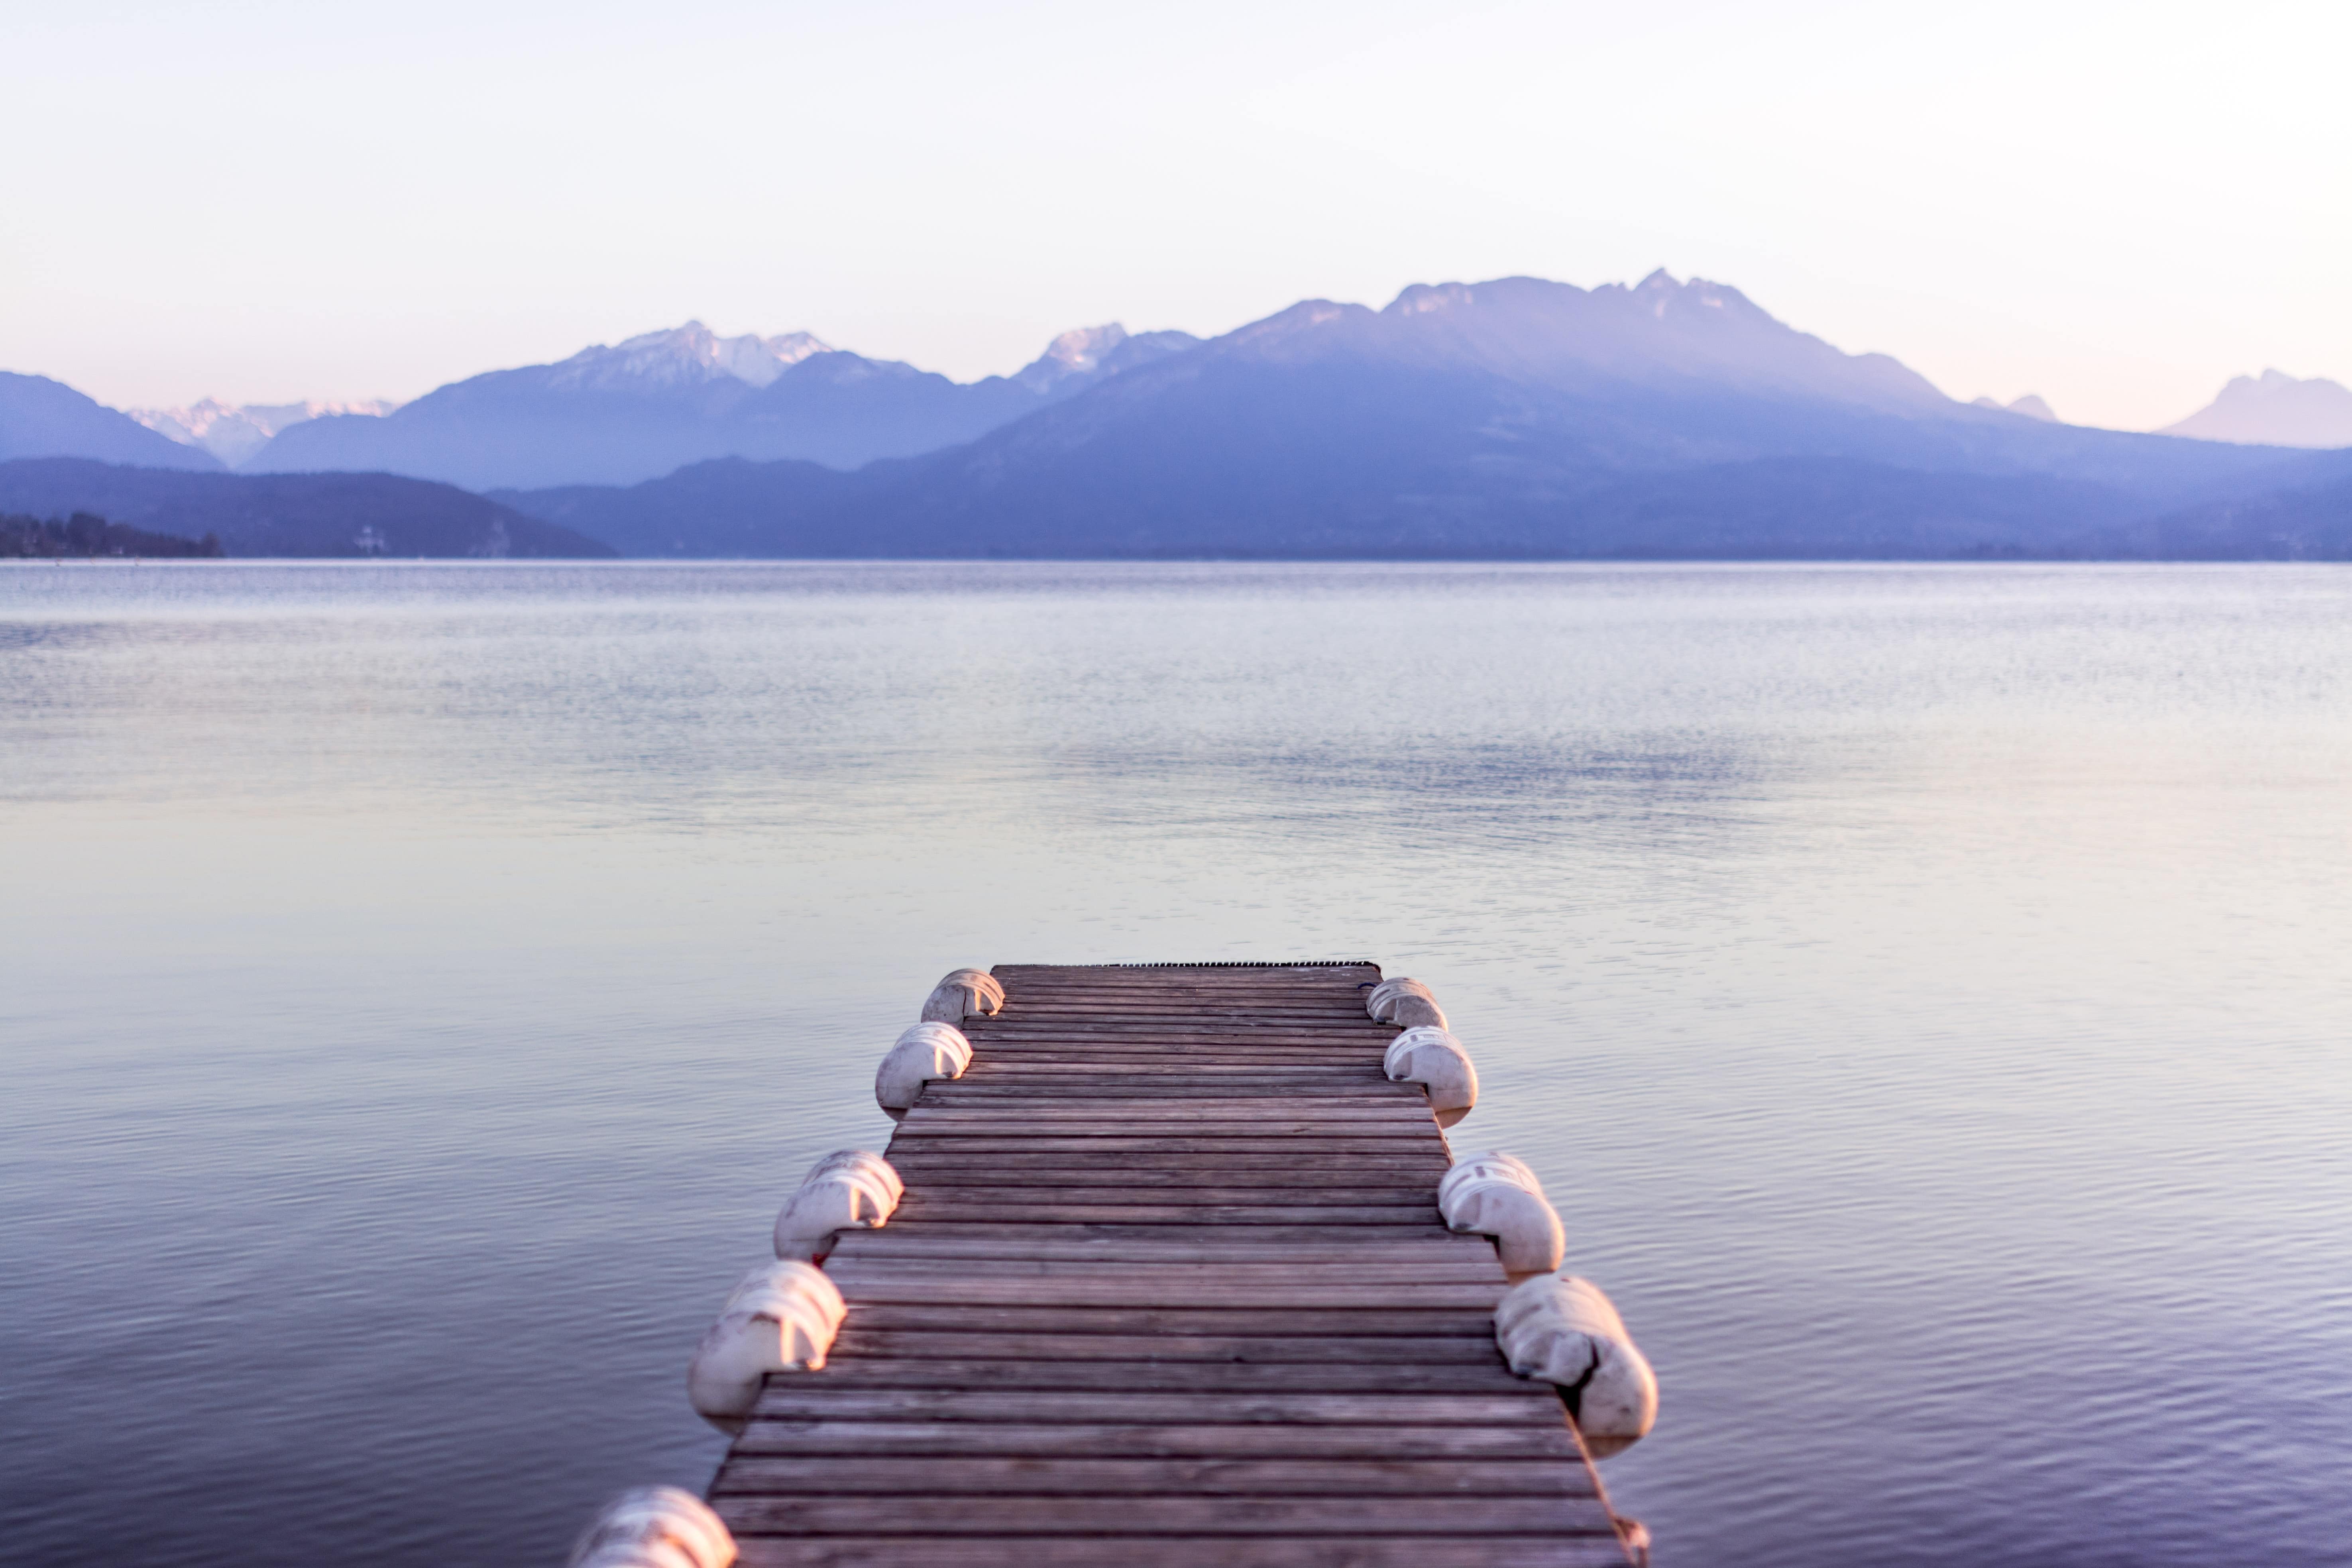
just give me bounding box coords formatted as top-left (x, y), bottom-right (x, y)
top-left (501, 273), bottom-right (2333, 560)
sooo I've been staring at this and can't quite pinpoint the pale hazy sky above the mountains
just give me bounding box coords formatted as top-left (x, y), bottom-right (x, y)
top-left (0, 0), bottom-right (2352, 428)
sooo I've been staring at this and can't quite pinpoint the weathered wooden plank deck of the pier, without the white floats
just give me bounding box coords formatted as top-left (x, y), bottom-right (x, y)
top-left (710, 964), bottom-right (1627, 1568)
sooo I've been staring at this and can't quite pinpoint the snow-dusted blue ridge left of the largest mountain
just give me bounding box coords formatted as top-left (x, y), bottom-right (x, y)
top-left (245, 322), bottom-right (1195, 489)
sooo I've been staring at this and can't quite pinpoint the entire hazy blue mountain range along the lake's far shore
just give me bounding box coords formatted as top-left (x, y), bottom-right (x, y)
top-left (0, 270), bottom-right (2352, 560)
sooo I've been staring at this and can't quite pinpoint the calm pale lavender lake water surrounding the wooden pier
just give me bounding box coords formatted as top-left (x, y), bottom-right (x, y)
top-left (0, 564), bottom-right (2352, 1568)
